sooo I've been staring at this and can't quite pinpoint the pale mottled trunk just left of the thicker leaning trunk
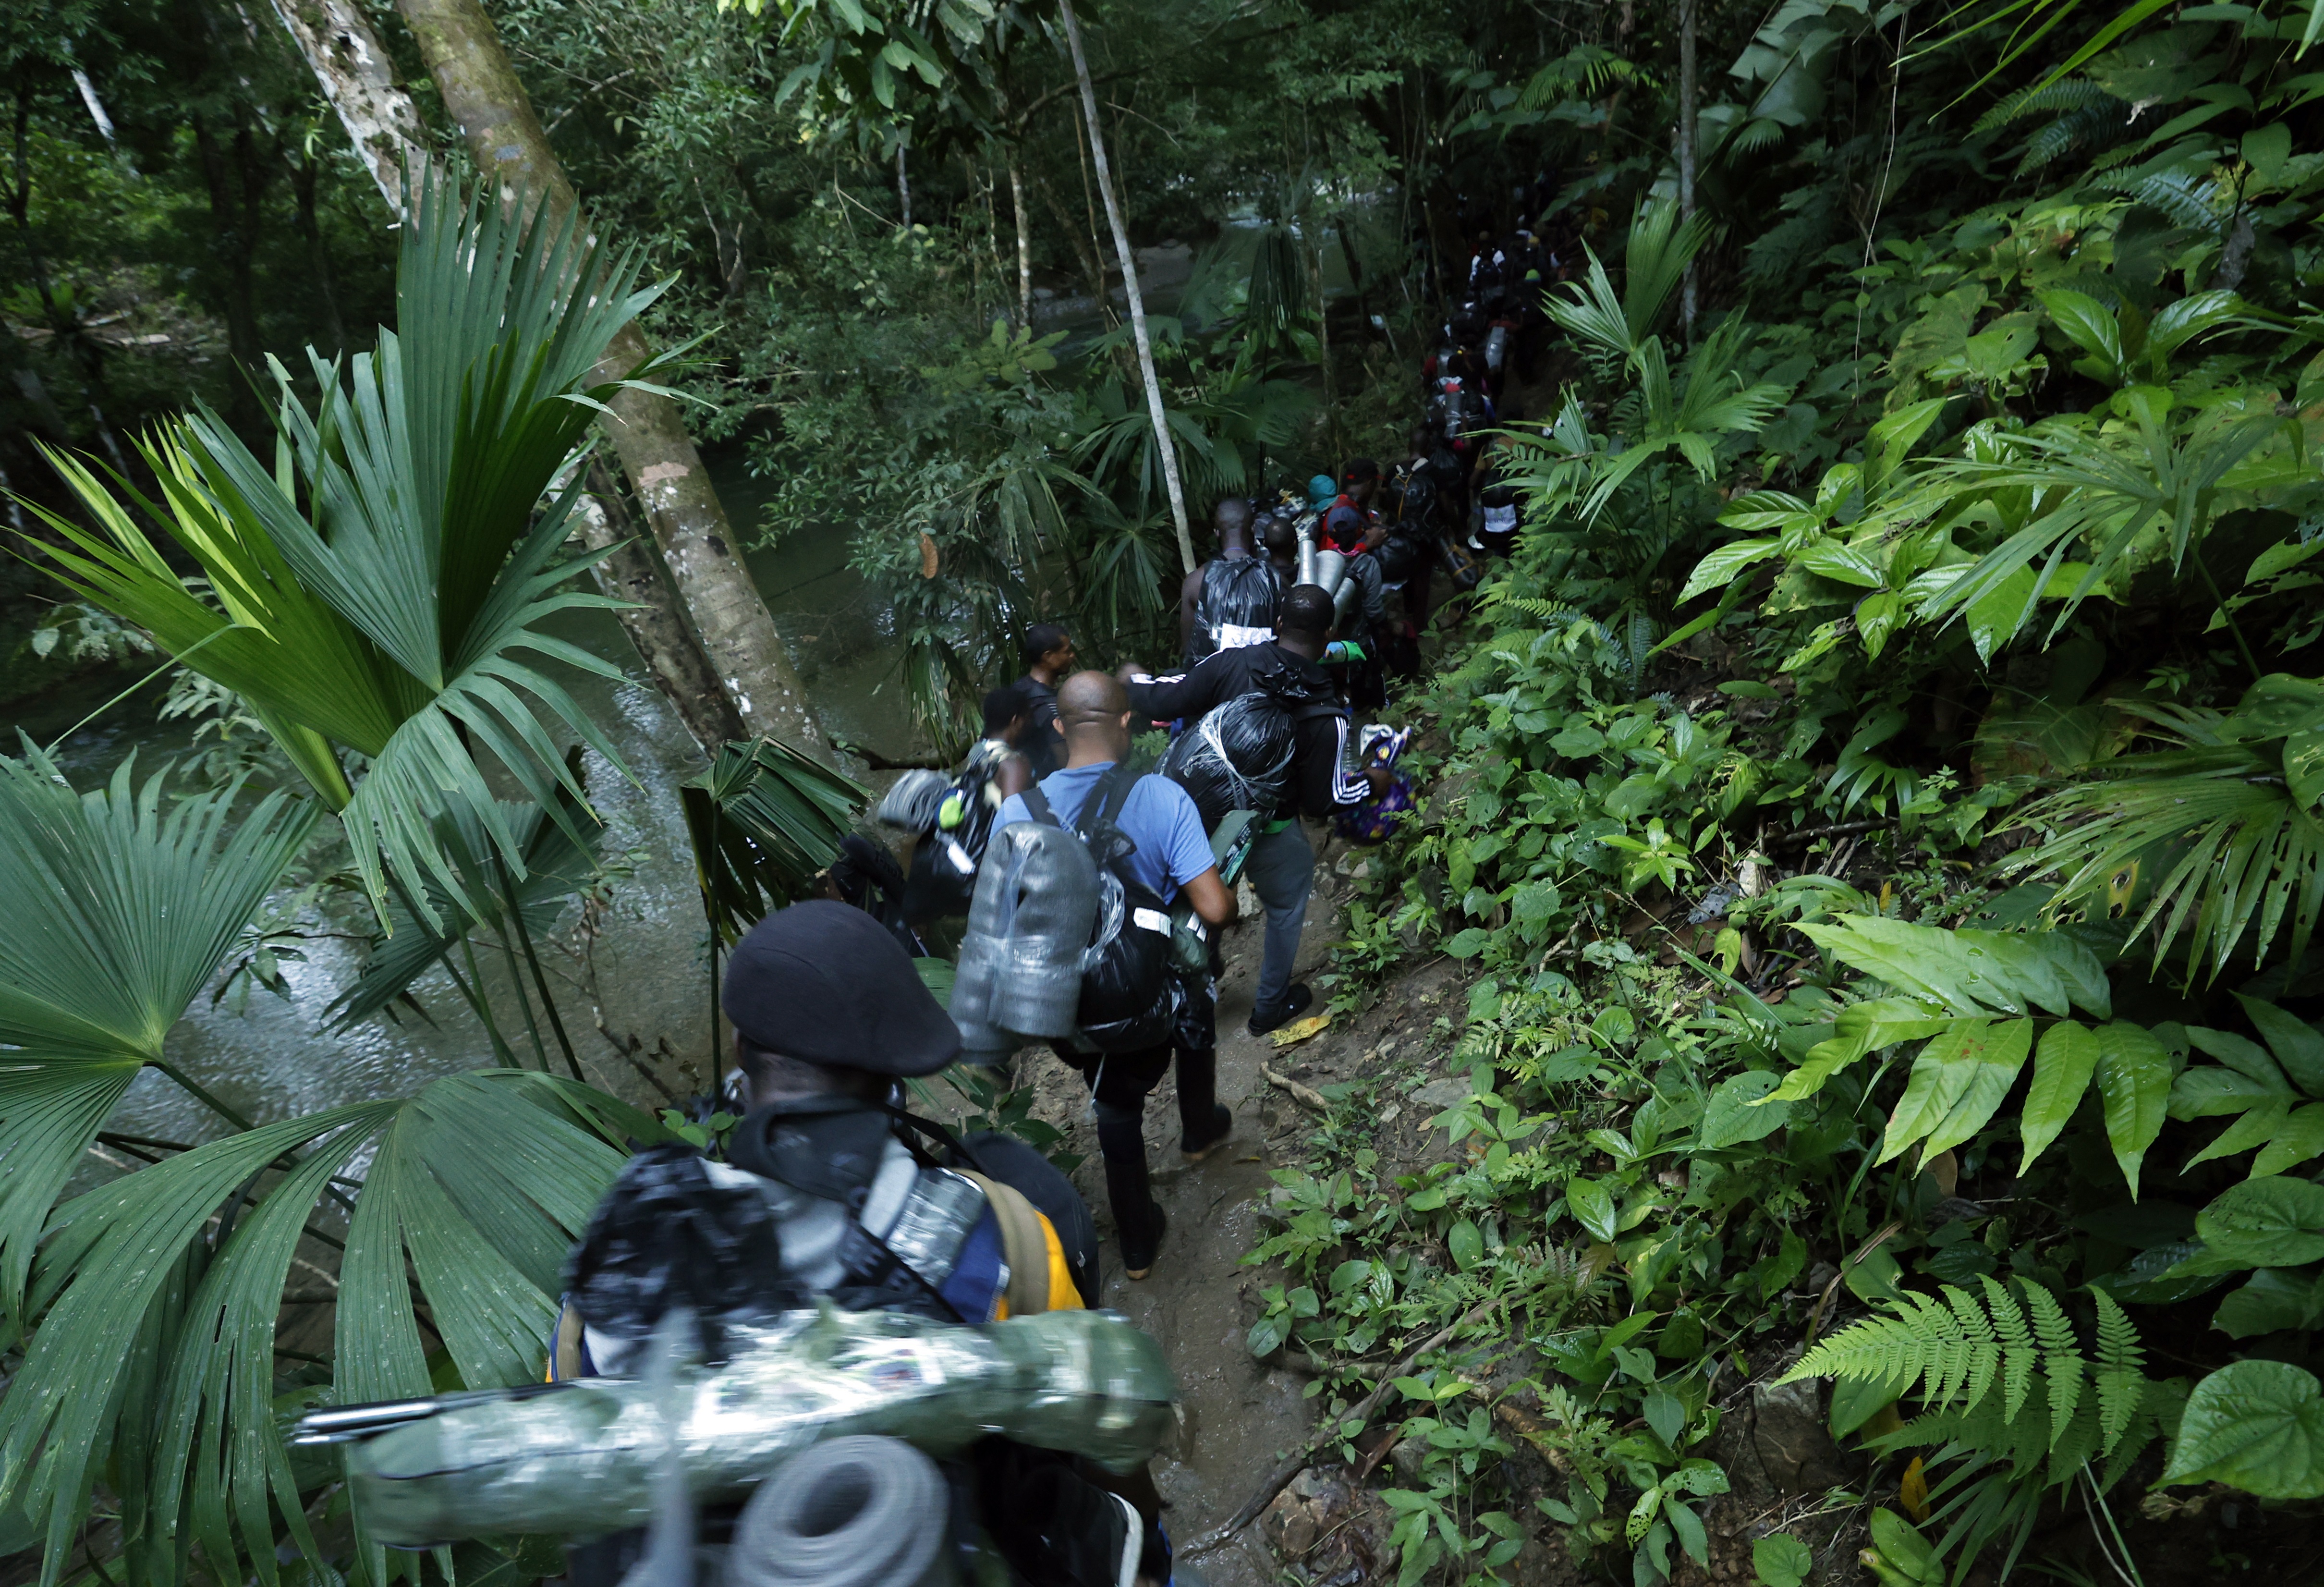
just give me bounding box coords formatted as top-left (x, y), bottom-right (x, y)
top-left (274, 0), bottom-right (799, 755)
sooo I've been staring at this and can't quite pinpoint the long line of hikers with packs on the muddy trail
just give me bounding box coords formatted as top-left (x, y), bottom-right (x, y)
top-left (353, 264), bottom-right (1543, 1587)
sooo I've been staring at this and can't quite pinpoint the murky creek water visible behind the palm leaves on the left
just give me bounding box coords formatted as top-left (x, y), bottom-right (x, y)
top-left (38, 455), bottom-right (913, 1150)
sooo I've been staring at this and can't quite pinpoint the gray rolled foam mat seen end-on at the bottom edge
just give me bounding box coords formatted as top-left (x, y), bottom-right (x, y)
top-left (725, 1436), bottom-right (950, 1587)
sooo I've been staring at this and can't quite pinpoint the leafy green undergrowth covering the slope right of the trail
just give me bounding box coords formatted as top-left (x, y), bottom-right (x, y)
top-left (1250, 176), bottom-right (2324, 1587)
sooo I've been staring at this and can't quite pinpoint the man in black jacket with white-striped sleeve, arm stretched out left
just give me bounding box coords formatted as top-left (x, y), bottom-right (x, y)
top-left (1125, 583), bottom-right (1387, 1037)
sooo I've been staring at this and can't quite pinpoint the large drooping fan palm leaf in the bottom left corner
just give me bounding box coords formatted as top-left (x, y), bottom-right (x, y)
top-left (0, 1069), bottom-right (662, 1582)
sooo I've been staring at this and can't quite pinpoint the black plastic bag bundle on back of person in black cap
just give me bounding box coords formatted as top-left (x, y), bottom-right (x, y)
top-left (565, 1146), bottom-right (811, 1359)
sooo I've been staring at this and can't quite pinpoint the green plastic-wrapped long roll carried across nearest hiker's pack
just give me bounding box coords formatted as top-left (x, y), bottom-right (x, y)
top-left (328, 1306), bottom-right (1178, 1548)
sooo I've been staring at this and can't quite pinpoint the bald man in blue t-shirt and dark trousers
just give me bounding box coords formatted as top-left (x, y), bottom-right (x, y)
top-left (992, 671), bottom-right (1234, 1304)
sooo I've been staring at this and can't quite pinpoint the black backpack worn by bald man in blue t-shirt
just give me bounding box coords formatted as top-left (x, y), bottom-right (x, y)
top-left (1020, 762), bottom-right (1178, 1052)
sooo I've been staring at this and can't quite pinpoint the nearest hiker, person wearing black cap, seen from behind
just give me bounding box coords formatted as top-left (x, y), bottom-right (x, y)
top-left (551, 899), bottom-right (1169, 1587)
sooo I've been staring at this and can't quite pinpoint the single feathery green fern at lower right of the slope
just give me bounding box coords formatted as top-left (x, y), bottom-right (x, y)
top-left (1780, 1278), bottom-right (2173, 1580)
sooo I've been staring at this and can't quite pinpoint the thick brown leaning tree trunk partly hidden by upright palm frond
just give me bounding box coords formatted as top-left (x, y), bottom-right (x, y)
top-left (397, 0), bottom-right (834, 762)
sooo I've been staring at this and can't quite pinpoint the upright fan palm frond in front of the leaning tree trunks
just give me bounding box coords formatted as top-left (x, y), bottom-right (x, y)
top-left (16, 165), bottom-right (674, 927)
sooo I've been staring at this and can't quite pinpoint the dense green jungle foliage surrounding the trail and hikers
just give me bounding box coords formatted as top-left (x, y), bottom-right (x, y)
top-left (0, 0), bottom-right (2324, 1587)
